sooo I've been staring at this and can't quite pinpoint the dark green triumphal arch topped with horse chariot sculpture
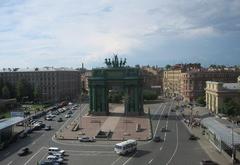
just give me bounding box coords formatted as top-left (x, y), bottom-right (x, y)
top-left (88, 55), bottom-right (143, 115)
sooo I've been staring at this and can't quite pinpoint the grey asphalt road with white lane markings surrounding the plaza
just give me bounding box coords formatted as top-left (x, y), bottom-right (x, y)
top-left (0, 101), bottom-right (209, 165)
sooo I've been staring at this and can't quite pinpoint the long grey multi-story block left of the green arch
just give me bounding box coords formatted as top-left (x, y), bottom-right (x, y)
top-left (0, 67), bottom-right (81, 102)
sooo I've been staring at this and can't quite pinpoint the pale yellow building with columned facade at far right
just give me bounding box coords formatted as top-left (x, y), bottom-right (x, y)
top-left (205, 81), bottom-right (240, 114)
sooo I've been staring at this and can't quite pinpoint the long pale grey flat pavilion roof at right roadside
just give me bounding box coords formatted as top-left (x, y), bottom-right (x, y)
top-left (201, 117), bottom-right (240, 147)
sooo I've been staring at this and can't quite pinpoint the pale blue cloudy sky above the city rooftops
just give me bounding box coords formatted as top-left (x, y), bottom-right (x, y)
top-left (0, 0), bottom-right (240, 68)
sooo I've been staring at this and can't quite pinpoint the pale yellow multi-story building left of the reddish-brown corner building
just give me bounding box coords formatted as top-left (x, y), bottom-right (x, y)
top-left (163, 69), bottom-right (183, 97)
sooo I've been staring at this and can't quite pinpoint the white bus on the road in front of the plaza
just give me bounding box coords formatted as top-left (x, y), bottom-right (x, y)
top-left (114, 139), bottom-right (137, 155)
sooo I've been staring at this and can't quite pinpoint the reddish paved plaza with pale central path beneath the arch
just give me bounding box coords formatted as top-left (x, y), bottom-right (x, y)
top-left (55, 105), bottom-right (151, 140)
